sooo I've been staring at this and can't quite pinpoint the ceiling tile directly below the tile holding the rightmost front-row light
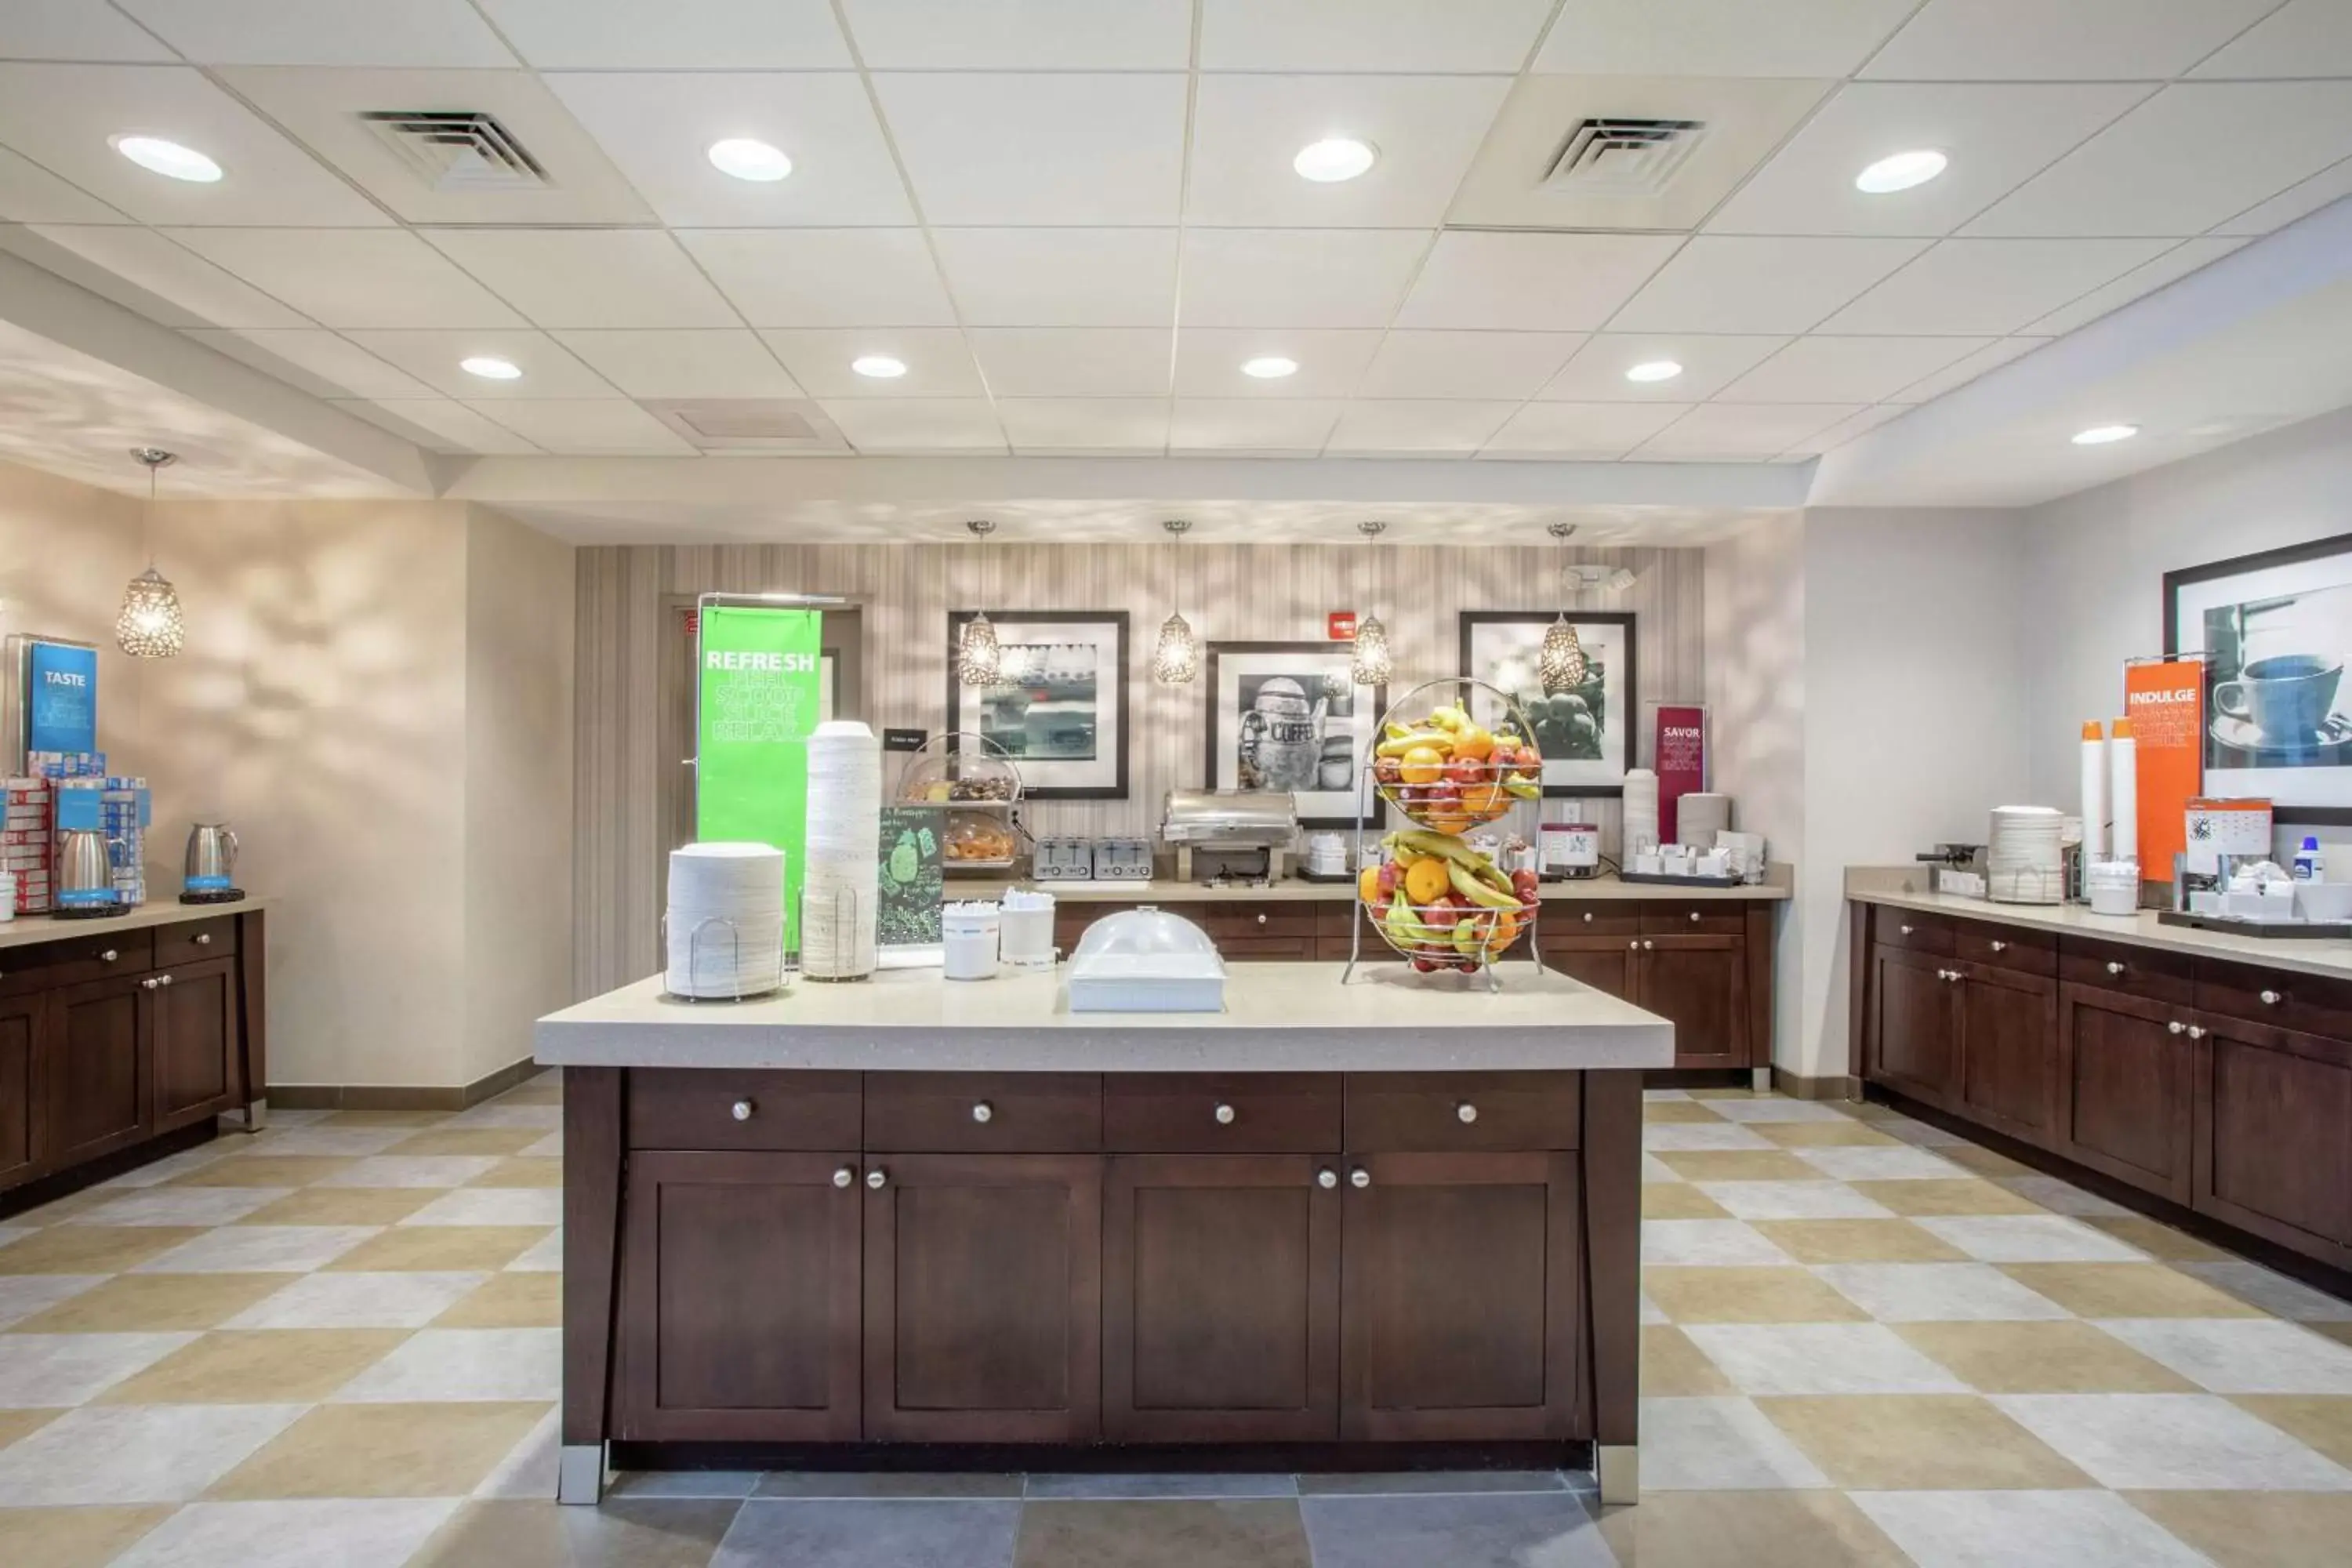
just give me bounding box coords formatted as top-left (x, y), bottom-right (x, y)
top-left (1609, 235), bottom-right (1929, 334)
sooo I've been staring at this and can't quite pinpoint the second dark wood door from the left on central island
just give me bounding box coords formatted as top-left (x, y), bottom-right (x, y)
top-left (866, 1154), bottom-right (1103, 1443)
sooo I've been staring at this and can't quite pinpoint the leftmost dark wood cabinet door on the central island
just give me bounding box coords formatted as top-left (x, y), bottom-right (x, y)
top-left (616, 1152), bottom-right (858, 1441)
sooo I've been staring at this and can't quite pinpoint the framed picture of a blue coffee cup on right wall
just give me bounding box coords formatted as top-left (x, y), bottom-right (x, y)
top-left (2164, 534), bottom-right (2352, 822)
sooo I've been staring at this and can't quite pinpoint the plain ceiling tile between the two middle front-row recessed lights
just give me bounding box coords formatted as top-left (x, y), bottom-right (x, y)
top-left (873, 73), bottom-right (1185, 226)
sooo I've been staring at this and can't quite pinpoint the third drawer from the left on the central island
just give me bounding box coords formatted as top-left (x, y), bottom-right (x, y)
top-left (1103, 1072), bottom-right (1341, 1154)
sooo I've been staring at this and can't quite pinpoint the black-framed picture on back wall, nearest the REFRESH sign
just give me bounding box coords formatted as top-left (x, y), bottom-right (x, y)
top-left (948, 609), bottom-right (1127, 799)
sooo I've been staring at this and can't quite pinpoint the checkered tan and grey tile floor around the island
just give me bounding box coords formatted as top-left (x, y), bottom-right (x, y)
top-left (0, 1076), bottom-right (2352, 1568)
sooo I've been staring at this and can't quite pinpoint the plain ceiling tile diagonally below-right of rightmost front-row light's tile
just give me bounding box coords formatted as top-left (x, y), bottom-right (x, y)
top-left (1820, 240), bottom-right (2171, 336)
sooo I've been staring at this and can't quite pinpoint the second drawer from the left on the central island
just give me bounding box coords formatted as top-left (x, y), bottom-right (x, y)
top-left (866, 1072), bottom-right (1103, 1154)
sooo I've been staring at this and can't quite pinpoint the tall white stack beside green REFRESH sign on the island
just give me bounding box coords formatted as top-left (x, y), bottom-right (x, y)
top-left (800, 720), bottom-right (882, 980)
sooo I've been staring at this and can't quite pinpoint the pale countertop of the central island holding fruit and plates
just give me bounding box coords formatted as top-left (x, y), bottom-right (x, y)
top-left (536, 959), bottom-right (1675, 1072)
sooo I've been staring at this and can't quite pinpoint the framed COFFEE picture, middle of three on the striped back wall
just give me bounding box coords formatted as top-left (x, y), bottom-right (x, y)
top-left (1202, 642), bottom-right (1388, 827)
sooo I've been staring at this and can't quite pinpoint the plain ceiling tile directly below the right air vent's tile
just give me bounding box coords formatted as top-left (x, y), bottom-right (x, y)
top-left (1397, 230), bottom-right (1682, 332)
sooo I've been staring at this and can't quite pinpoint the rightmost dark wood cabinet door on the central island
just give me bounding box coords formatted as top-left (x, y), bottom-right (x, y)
top-left (1341, 1154), bottom-right (1585, 1441)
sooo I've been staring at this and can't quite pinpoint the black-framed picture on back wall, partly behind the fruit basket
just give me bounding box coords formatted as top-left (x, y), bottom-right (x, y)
top-left (1461, 609), bottom-right (1639, 797)
